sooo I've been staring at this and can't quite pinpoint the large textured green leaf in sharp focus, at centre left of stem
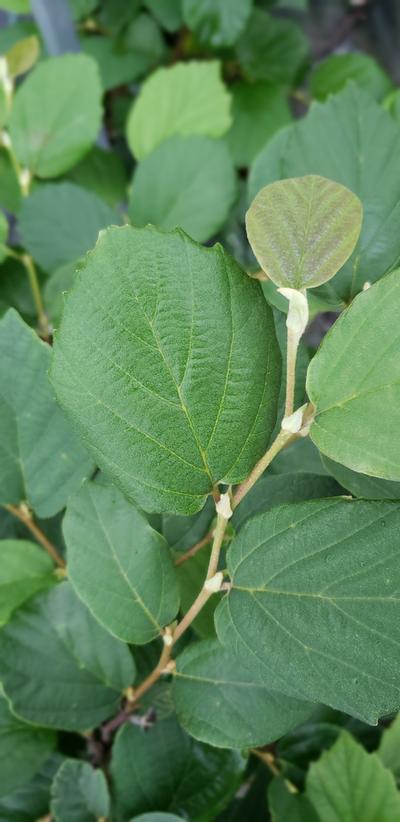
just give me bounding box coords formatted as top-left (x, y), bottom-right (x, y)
top-left (52, 227), bottom-right (280, 514)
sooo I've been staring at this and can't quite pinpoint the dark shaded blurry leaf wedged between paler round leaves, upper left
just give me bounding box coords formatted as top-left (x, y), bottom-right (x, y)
top-left (67, 146), bottom-right (127, 206)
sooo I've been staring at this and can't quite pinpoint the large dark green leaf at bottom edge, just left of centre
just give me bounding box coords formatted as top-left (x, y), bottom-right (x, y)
top-left (110, 717), bottom-right (245, 822)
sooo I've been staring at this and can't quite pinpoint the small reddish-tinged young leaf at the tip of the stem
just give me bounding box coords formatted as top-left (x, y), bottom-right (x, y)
top-left (246, 174), bottom-right (362, 291)
